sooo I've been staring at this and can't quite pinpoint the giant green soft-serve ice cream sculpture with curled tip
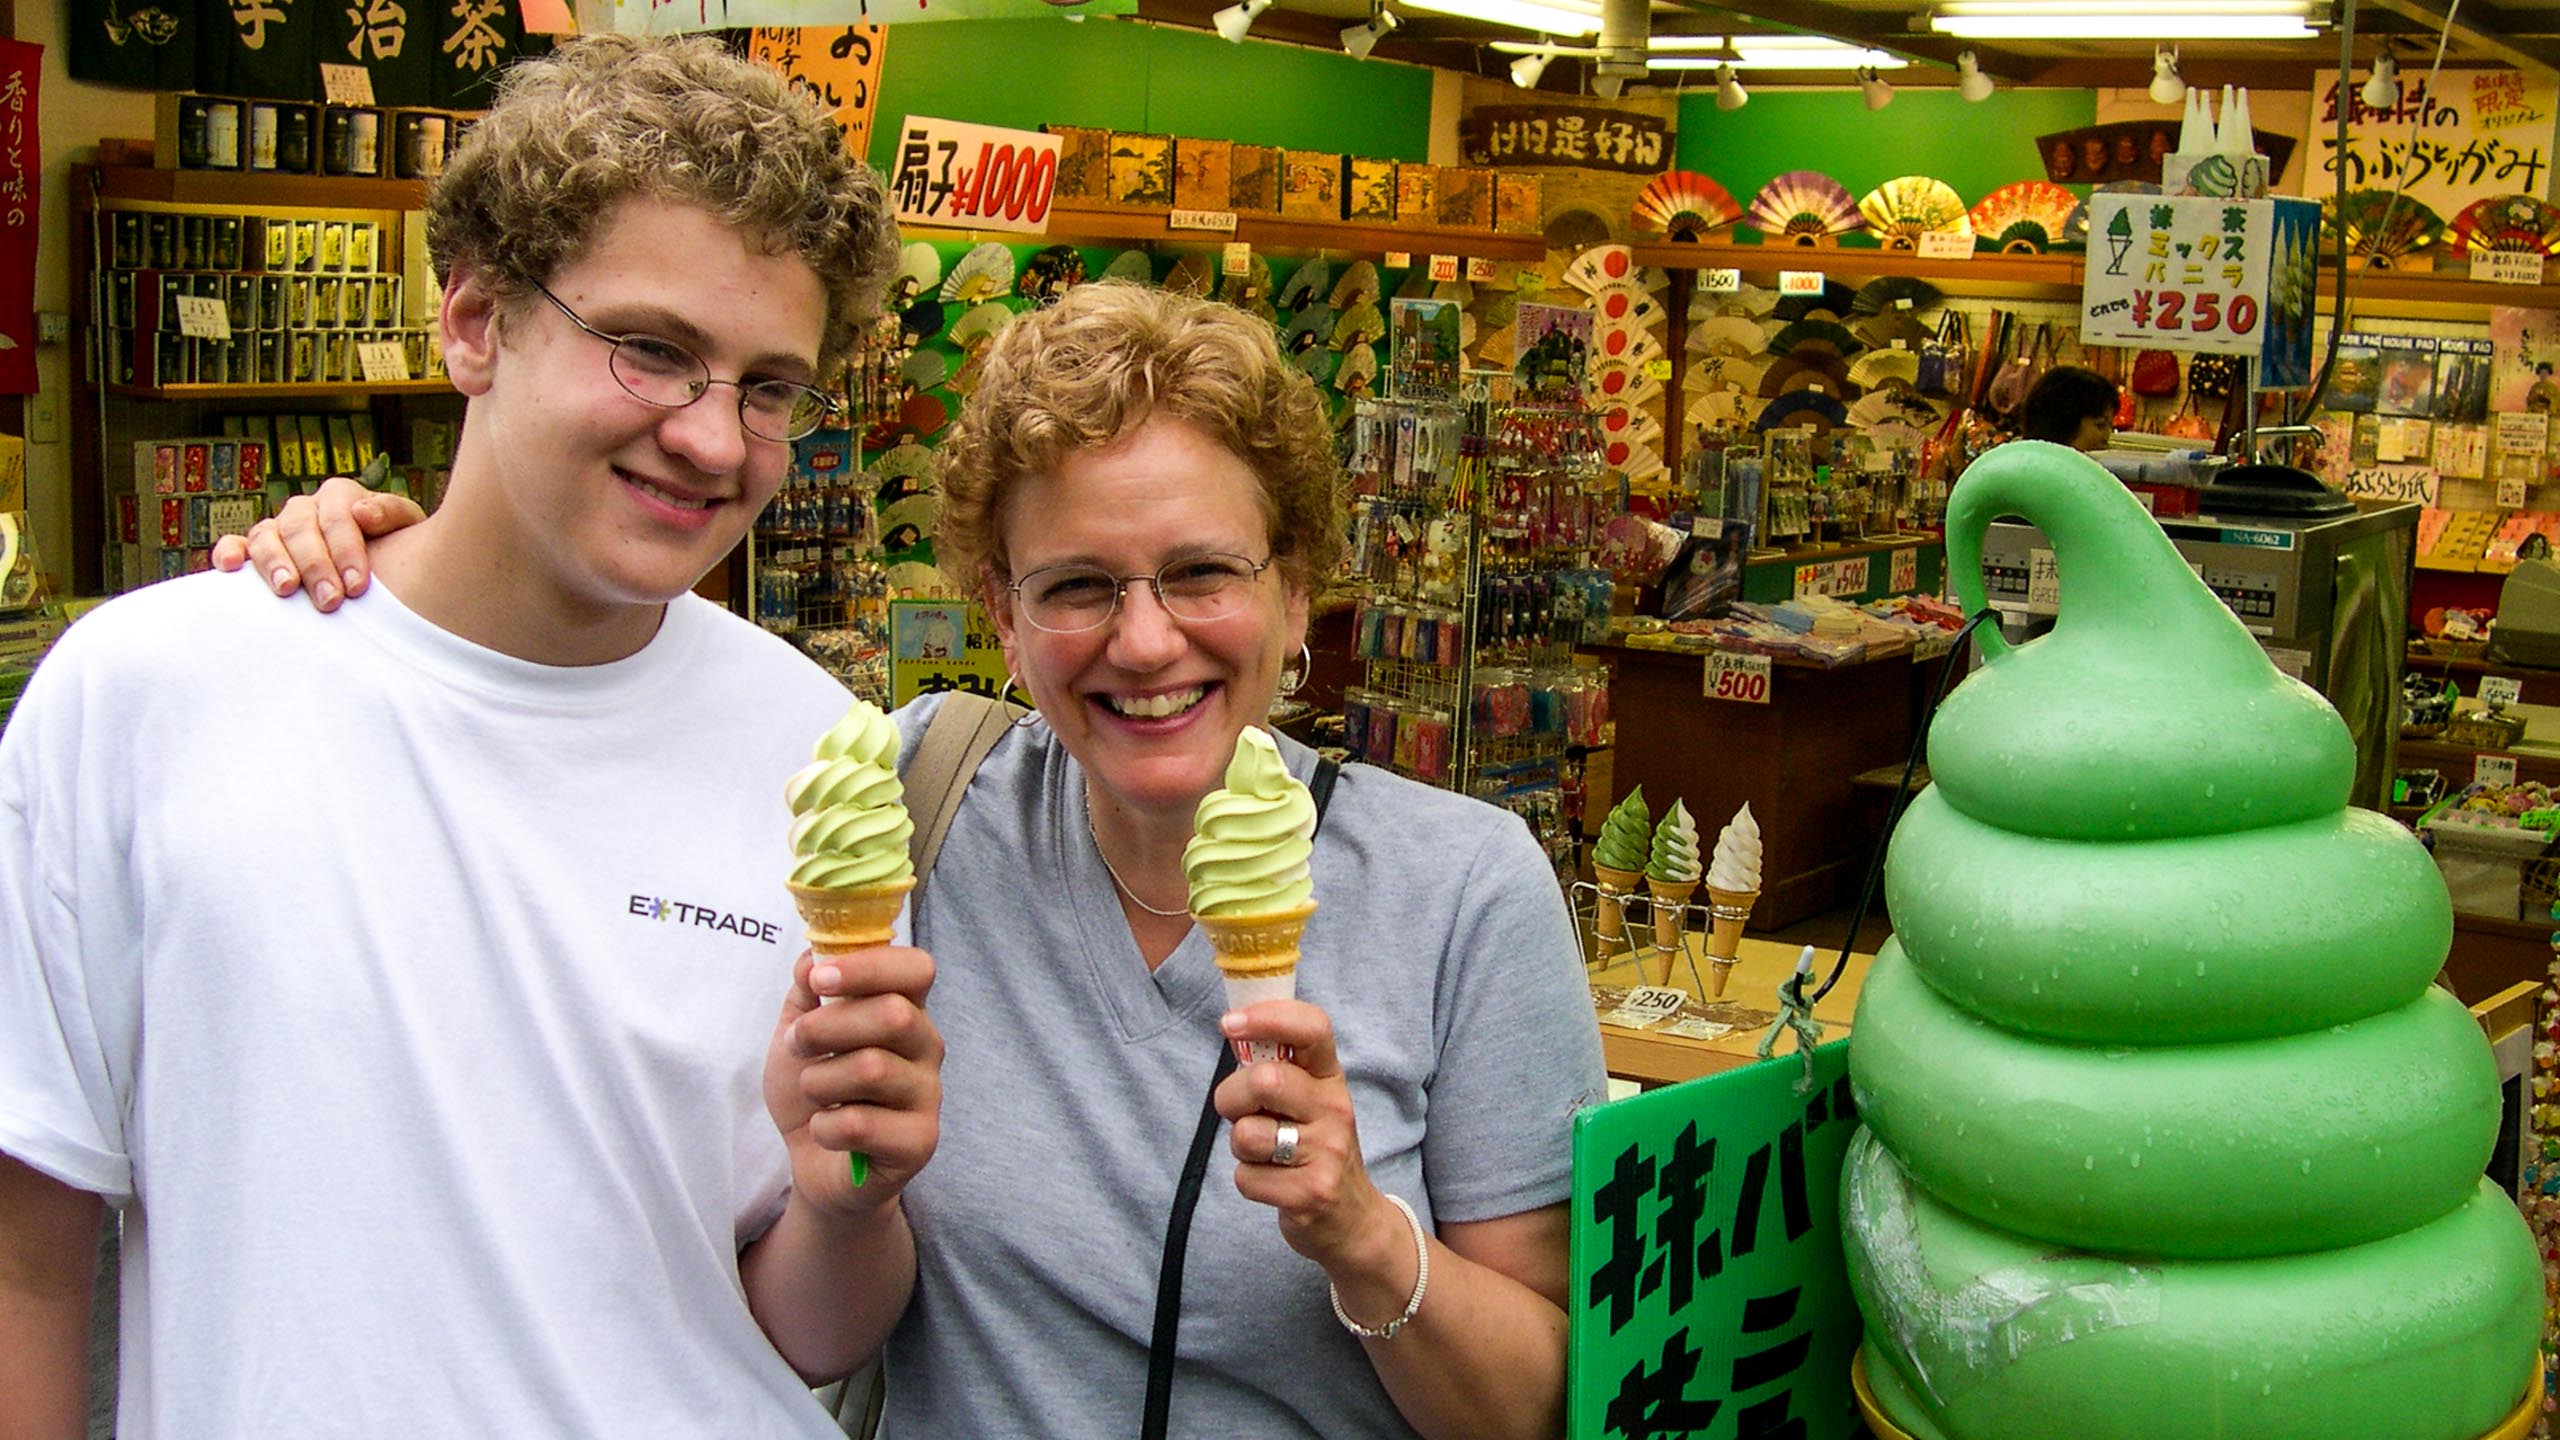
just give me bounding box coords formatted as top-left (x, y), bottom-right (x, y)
top-left (1841, 441), bottom-right (2542, 1440)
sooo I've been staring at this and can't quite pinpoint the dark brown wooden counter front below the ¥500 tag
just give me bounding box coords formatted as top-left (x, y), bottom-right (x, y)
top-left (1585, 646), bottom-right (1935, 930)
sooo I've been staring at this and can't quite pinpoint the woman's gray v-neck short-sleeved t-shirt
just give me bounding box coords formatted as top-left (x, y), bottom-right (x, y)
top-left (881, 700), bottom-right (1605, 1440)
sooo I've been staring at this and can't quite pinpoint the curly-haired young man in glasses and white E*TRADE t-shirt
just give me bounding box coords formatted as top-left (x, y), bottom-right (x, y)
top-left (0, 38), bottom-right (942, 1440)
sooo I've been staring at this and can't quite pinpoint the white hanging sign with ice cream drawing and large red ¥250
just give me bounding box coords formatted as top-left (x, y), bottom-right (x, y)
top-left (2081, 190), bottom-right (2319, 389)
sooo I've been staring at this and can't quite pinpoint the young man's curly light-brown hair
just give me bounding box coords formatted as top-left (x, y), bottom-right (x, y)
top-left (428, 33), bottom-right (899, 369)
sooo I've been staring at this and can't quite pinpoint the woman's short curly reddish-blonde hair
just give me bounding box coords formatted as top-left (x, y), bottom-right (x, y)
top-left (934, 282), bottom-right (1344, 597)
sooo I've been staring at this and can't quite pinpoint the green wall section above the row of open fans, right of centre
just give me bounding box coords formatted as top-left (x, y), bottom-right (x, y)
top-left (1679, 88), bottom-right (2097, 219)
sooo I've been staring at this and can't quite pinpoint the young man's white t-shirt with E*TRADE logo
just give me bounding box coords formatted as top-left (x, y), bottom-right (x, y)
top-left (0, 574), bottom-right (845, 1440)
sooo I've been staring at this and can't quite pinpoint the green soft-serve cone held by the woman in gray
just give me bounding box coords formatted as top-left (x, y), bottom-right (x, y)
top-left (1183, 725), bottom-right (1316, 1063)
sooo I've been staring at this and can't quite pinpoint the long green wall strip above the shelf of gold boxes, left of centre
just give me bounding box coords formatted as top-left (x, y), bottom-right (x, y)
top-left (870, 18), bottom-right (1431, 172)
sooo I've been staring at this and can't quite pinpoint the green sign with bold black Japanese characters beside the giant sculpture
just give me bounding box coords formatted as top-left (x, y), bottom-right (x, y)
top-left (1567, 1040), bottom-right (1864, 1440)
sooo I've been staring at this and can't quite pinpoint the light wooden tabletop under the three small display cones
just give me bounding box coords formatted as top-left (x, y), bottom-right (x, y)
top-left (1590, 930), bottom-right (1874, 1089)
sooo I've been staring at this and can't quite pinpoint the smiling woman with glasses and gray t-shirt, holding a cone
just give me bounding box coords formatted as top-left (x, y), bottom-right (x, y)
top-left (230, 284), bottom-right (1603, 1440)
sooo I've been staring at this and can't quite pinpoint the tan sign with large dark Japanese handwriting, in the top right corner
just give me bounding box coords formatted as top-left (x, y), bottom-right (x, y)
top-left (2301, 64), bottom-right (2560, 220)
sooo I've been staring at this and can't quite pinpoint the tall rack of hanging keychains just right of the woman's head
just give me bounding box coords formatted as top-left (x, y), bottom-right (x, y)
top-left (1344, 300), bottom-right (1610, 871)
